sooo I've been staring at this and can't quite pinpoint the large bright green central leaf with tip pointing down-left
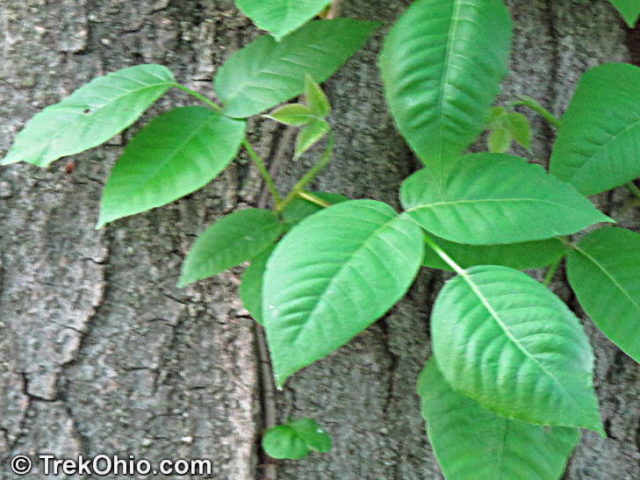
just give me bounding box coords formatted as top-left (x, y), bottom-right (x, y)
top-left (263, 200), bottom-right (424, 386)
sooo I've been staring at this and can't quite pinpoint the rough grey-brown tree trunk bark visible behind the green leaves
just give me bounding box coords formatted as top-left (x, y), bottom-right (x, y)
top-left (0, 0), bottom-right (640, 480)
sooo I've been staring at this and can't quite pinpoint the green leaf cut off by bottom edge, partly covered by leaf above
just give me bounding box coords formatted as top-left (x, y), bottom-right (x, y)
top-left (418, 359), bottom-right (580, 480)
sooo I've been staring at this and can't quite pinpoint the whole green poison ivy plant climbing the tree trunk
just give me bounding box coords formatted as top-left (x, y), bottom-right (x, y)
top-left (2, 0), bottom-right (640, 480)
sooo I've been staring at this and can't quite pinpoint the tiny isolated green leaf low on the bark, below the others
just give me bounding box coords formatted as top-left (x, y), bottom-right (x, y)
top-left (262, 418), bottom-right (332, 460)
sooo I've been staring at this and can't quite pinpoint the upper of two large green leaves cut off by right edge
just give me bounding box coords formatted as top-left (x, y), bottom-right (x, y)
top-left (551, 63), bottom-right (640, 195)
